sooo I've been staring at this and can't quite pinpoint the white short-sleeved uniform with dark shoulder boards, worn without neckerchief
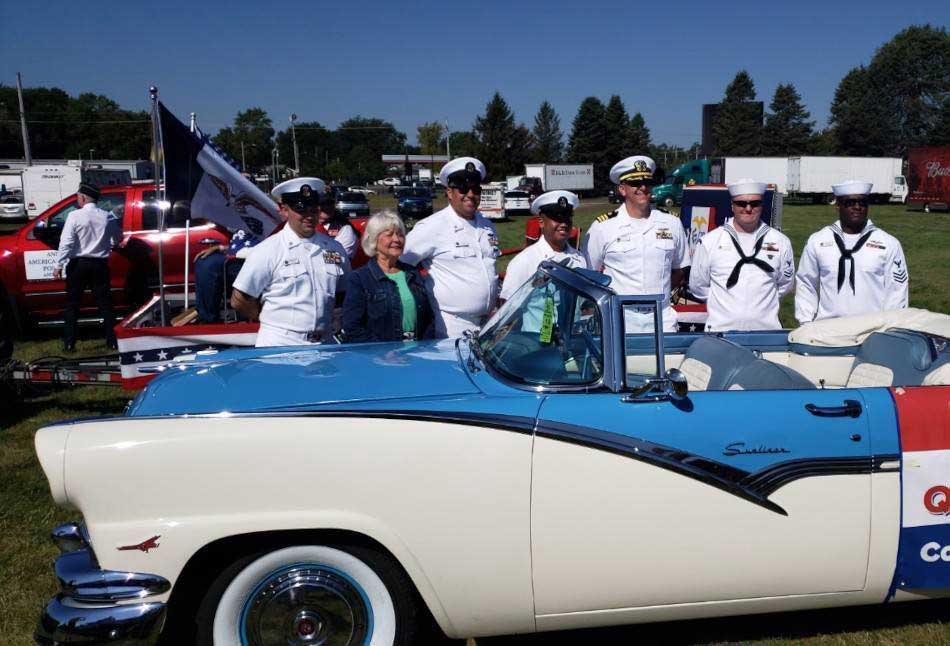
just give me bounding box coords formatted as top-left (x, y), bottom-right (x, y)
top-left (584, 204), bottom-right (689, 332)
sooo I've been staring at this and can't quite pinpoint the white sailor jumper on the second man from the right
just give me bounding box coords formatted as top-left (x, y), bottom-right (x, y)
top-left (689, 223), bottom-right (795, 332)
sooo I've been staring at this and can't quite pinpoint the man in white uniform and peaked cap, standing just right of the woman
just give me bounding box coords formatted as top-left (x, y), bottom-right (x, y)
top-left (401, 157), bottom-right (501, 337)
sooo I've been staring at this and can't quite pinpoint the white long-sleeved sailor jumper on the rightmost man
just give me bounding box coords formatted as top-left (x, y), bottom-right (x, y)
top-left (795, 220), bottom-right (908, 323)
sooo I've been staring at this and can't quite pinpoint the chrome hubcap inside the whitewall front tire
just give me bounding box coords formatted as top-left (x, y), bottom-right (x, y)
top-left (241, 565), bottom-right (369, 646)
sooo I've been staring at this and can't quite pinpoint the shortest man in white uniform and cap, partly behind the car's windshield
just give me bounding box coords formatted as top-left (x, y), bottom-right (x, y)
top-left (501, 191), bottom-right (587, 332)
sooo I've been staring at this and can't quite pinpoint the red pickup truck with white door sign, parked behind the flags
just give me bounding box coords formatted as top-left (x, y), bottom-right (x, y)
top-left (0, 184), bottom-right (230, 332)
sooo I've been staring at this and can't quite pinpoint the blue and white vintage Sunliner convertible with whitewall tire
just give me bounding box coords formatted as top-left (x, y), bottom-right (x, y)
top-left (36, 263), bottom-right (950, 644)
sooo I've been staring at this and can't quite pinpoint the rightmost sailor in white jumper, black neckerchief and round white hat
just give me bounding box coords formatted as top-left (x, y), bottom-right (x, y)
top-left (795, 181), bottom-right (908, 323)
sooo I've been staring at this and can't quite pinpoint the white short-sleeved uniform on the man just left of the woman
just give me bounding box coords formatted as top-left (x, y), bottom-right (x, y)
top-left (234, 226), bottom-right (350, 341)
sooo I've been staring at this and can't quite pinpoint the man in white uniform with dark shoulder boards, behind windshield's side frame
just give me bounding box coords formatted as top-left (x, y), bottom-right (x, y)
top-left (583, 155), bottom-right (689, 332)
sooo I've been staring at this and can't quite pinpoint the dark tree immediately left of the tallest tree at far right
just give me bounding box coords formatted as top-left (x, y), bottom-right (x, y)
top-left (829, 65), bottom-right (897, 156)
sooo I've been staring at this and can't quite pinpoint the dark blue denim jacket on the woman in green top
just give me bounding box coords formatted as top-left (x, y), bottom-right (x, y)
top-left (342, 259), bottom-right (433, 343)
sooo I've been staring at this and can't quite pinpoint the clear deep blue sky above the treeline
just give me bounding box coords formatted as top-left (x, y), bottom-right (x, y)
top-left (0, 0), bottom-right (950, 152)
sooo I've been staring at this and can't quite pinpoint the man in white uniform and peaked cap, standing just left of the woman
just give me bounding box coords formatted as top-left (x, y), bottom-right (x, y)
top-left (231, 177), bottom-right (350, 347)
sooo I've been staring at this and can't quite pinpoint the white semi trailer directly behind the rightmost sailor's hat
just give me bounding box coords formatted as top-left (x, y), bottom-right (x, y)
top-left (788, 157), bottom-right (907, 202)
